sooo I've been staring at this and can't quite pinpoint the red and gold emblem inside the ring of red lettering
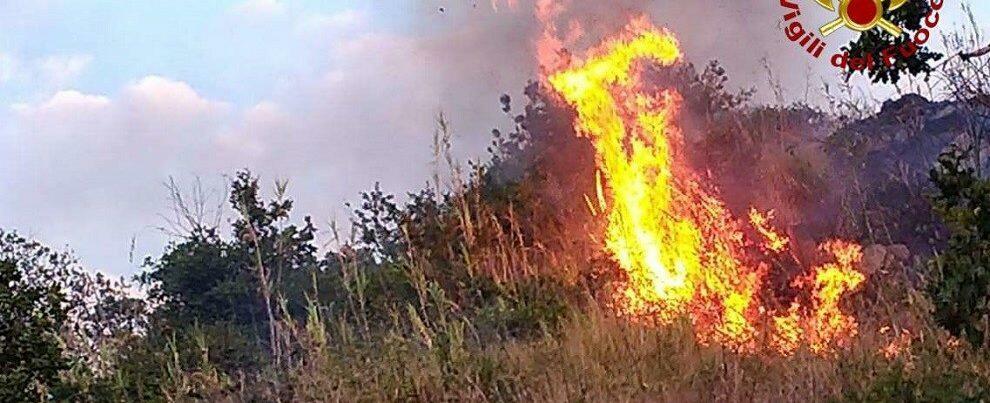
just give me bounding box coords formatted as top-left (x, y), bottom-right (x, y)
top-left (815, 0), bottom-right (908, 36)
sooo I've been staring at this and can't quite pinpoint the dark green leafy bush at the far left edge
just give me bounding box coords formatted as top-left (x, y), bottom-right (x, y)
top-left (0, 230), bottom-right (145, 401)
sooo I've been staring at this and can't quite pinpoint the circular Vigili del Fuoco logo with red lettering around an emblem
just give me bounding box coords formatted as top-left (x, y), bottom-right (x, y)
top-left (780, 0), bottom-right (944, 71)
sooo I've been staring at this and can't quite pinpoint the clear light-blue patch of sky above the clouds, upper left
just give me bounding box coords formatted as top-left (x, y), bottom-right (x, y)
top-left (0, 0), bottom-right (401, 105)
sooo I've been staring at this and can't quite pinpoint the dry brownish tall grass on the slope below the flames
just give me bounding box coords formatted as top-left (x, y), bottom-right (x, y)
top-left (128, 120), bottom-right (990, 401)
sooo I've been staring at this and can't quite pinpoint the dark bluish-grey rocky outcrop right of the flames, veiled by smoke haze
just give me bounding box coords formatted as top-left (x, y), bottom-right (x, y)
top-left (825, 94), bottom-right (971, 254)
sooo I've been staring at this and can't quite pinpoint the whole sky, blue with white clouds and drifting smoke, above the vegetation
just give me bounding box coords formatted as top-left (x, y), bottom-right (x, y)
top-left (0, 0), bottom-right (990, 275)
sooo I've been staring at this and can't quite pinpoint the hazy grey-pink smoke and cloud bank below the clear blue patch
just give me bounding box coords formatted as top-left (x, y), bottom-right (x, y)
top-left (0, 0), bottom-right (960, 274)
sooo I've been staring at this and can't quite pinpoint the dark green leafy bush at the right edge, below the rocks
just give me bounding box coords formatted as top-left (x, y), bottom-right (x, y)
top-left (929, 150), bottom-right (990, 345)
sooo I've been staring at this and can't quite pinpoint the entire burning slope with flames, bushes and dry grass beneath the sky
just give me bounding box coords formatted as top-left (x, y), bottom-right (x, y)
top-left (0, 0), bottom-right (990, 401)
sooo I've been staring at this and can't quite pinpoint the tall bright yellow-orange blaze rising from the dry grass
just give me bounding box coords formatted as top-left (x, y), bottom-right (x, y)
top-left (545, 18), bottom-right (863, 354)
